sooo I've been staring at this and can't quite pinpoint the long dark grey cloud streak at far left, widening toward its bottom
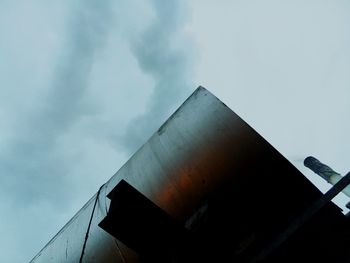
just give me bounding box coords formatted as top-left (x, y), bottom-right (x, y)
top-left (0, 1), bottom-right (111, 206)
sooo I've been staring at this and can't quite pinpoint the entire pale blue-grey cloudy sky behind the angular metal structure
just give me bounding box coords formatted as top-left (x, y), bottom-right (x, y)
top-left (0, 0), bottom-right (350, 263)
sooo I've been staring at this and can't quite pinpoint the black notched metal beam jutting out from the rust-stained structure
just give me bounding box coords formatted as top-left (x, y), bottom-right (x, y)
top-left (99, 180), bottom-right (190, 263)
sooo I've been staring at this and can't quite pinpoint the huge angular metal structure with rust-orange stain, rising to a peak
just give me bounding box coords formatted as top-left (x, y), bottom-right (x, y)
top-left (31, 87), bottom-right (350, 263)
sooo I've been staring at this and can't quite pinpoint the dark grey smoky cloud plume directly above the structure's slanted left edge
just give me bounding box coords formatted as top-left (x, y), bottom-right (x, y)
top-left (120, 0), bottom-right (193, 153)
